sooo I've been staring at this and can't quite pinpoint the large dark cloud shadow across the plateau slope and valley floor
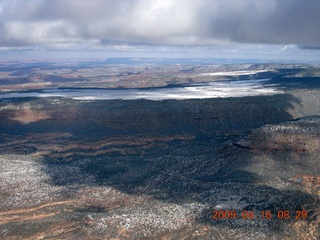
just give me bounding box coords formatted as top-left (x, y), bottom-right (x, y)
top-left (0, 88), bottom-right (318, 236)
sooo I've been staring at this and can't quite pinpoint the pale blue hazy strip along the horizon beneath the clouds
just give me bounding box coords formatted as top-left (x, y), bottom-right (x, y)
top-left (0, 47), bottom-right (320, 64)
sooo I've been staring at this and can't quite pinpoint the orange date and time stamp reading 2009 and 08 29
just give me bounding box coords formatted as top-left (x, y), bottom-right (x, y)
top-left (212, 209), bottom-right (308, 220)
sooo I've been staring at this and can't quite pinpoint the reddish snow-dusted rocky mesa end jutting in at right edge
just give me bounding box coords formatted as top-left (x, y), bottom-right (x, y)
top-left (225, 116), bottom-right (320, 182)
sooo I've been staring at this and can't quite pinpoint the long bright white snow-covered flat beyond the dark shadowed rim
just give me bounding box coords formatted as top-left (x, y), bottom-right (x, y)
top-left (0, 79), bottom-right (283, 100)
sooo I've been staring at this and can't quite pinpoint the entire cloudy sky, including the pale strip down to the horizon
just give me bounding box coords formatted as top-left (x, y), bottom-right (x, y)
top-left (0, 0), bottom-right (320, 61)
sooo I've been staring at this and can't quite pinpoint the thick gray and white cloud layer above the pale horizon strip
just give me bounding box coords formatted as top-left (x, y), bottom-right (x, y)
top-left (0, 0), bottom-right (320, 47)
